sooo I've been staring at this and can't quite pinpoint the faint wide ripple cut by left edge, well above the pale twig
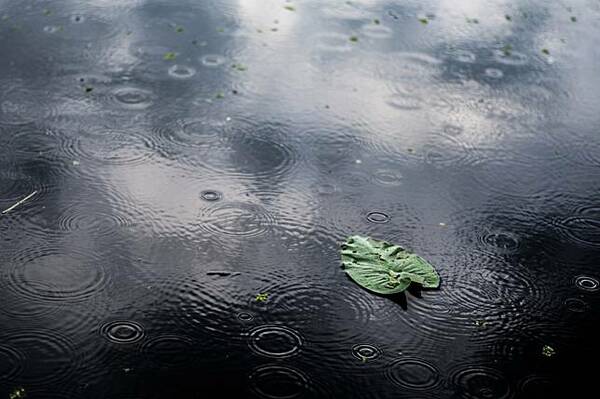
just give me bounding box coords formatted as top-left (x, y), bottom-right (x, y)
top-left (0, 83), bottom-right (58, 125)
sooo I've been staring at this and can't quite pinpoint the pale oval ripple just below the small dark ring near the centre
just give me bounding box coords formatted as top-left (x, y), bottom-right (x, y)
top-left (199, 202), bottom-right (276, 238)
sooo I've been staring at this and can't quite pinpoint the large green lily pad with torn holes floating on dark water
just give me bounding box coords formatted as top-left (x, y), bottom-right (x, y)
top-left (341, 236), bottom-right (440, 295)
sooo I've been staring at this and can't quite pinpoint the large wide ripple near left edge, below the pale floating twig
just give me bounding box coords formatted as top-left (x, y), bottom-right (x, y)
top-left (7, 246), bottom-right (109, 301)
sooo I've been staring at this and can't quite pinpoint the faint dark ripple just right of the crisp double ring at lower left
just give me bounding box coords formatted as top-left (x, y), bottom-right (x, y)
top-left (142, 335), bottom-right (198, 368)
